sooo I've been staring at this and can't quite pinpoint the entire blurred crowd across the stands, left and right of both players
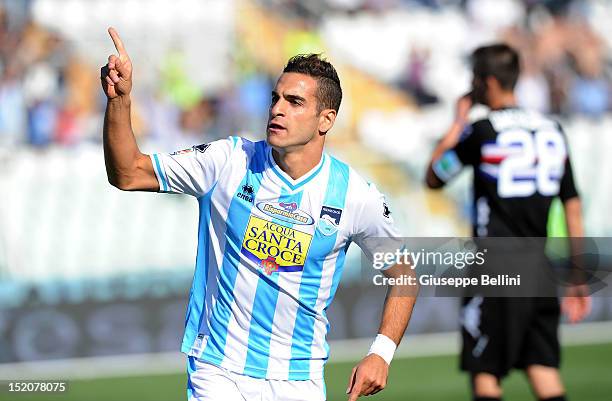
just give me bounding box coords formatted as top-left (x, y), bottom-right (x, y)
top-left (0, 0), bottom-right (611, 149)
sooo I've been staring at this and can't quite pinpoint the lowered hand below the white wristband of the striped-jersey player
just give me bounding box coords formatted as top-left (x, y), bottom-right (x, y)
top-left (346, 354), bottom-right (389, 401)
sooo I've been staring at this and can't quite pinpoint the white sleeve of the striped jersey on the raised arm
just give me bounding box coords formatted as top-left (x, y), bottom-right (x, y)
top-left (150, 137), bottom-right (237, 197)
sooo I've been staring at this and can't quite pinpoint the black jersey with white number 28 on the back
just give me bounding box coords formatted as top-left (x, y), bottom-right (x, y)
top-left (433, 108), bottom-right (578, 237)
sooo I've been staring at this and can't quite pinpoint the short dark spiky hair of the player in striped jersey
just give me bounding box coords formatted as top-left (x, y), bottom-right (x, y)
top-left (283, 54), bottom-right (342, 113)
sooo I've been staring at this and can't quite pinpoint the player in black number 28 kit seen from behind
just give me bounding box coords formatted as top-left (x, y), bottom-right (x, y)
top-left (426, 44), bottom-right (590, 401)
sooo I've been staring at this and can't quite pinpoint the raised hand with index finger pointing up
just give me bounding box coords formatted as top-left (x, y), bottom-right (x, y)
top-left (100, 28), bottom-right (132, 99)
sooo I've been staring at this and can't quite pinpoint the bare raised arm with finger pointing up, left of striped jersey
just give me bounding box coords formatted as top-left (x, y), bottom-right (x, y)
top-left (100, 28), bottom-right (159, 191)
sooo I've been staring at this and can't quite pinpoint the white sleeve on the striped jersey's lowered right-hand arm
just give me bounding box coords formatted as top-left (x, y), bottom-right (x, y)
top-left (352, 184), bottom-right (404, 270)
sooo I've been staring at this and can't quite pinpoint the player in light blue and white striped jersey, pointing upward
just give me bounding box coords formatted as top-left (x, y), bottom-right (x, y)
top-left (101, 28), bottom-right (415, 401)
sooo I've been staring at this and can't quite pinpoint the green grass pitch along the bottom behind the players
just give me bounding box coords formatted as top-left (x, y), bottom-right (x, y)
top-left (0, 343), bottom-right (612, 401)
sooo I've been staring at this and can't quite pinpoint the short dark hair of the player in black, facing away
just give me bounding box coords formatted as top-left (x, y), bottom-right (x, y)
top-left (472, 43), bottom-right (521, 90)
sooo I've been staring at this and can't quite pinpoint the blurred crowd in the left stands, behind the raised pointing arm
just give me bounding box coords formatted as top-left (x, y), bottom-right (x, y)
top-left (0, 0), bottom-right (273, 151)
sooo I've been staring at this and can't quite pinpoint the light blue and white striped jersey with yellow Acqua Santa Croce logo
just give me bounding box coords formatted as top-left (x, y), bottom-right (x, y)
top-left (151, 137), bottom-right (398, 380)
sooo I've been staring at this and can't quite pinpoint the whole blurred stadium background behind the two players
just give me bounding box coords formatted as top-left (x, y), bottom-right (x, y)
top-left (0, 0), bottom-right (612, 401)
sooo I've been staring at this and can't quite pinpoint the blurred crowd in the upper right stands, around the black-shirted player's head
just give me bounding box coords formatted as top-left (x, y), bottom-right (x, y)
top-left (262, 0), bottom-right (611, 114)
